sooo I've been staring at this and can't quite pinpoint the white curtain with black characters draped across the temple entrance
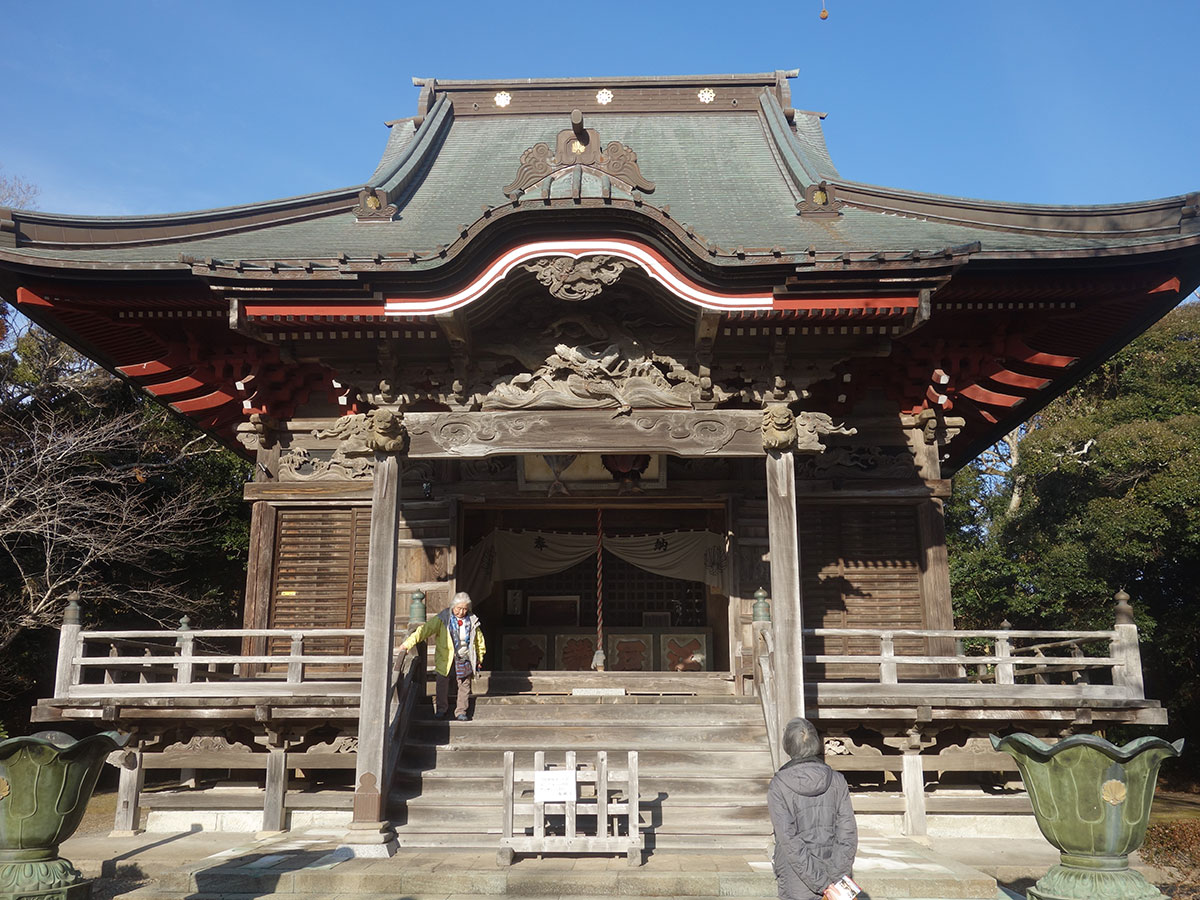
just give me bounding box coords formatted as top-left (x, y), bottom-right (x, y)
top-left (460, 528), bottom-right (726, 596)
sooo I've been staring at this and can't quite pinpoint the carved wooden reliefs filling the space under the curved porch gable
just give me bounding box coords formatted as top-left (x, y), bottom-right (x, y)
top-left (362, 300), bottom-right (864, 413)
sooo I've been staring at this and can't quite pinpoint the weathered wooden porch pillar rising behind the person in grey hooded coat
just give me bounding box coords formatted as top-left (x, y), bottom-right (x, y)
top-left (767, 450), bottom-right (804, 734)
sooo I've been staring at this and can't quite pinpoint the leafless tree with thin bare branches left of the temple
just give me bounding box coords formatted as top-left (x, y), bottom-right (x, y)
top-left (0, 412), bottom-right (228, 650)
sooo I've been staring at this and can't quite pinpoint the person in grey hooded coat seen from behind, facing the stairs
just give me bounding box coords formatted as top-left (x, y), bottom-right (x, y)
top-left (767, 719), bottom-right (858, 900)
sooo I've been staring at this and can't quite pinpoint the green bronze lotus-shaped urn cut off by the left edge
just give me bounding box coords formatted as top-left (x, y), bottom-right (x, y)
top-left (0, 731), bottom-right (130, 900)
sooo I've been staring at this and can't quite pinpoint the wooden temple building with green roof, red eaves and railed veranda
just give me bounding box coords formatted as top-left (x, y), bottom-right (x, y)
top-left (0, 71), bottom-right (1200, 847)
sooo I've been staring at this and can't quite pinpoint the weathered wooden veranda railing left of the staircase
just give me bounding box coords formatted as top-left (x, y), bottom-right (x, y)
top-left (54, 618), bottom-right (408, 700)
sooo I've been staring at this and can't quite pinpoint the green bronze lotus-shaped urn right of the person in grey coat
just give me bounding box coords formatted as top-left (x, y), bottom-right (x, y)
top-left (991, 734), bottom-right (1183, 900)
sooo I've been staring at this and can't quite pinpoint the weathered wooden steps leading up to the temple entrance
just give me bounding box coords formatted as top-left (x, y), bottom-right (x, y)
top-left (390, 672), bottom-right (772, 858)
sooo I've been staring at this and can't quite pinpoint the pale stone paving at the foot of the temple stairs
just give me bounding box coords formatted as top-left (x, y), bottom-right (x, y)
top-left (62, 830), bottom-right (1032, 900)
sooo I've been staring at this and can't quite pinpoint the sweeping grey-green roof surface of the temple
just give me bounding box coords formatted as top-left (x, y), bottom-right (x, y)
top-left (0, 78), bottom-right (1198, 268)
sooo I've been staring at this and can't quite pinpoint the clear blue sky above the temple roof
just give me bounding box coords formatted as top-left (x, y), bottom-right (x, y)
top-left (0, 0), bottom-right (1200, 215)
